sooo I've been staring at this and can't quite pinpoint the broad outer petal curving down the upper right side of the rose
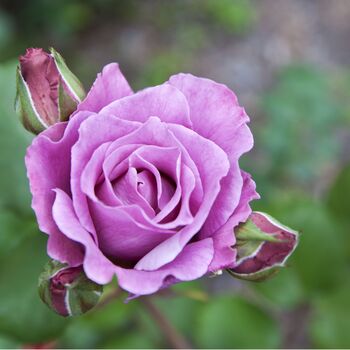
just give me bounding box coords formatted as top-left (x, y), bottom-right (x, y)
top-left (169, 74), bottom-right (253, 237)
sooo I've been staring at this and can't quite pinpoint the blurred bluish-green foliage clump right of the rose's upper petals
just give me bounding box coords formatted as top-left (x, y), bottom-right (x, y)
top-left (257, 66), bottom-right (345, 193)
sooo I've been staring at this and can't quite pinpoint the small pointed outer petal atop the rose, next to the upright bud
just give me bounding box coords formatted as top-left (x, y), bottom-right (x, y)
top-left (77, 63), bottom-right (133, 112)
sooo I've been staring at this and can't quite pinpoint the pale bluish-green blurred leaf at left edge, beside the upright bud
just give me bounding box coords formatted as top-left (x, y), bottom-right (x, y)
top-left (0, 63), bottom-right (31, 213)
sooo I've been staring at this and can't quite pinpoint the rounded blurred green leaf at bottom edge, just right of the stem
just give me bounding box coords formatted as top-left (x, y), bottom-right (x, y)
top-left (193, 296), bottom-right (281, 348)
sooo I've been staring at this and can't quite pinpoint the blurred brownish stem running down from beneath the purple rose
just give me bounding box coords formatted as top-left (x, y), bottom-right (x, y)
top-left (139, 297), bottom-right (191, 349)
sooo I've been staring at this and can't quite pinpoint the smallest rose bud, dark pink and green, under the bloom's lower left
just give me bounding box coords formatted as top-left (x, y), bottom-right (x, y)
top-left (39, 260), bottom-right (103, 317)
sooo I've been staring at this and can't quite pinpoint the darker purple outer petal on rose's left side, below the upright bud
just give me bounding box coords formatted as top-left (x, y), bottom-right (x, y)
top-left (25, 112), bottom-right (91, 266)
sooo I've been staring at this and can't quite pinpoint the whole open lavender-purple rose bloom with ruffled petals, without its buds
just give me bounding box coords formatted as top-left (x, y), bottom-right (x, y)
top-left (26, 63), bottom-right (258, 295)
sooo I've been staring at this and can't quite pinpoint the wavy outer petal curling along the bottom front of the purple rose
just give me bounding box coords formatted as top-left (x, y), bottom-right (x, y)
top-left (53, 190), bottom-right (214, 295)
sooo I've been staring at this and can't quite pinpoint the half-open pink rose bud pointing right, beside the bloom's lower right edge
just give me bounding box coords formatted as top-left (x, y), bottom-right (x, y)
top-left (228, 212), bottom-right (298, 281)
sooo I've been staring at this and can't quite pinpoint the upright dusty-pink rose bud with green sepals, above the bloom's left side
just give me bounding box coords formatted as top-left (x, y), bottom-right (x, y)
top-left (15, 48), bottom-right (85, 134)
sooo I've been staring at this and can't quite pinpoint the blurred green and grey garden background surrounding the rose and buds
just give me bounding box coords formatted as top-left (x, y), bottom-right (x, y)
top-left (0, 0), bottom-right (350, 348)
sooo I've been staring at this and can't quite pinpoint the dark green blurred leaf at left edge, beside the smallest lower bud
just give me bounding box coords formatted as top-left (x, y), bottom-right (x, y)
top-left (0, 233), bottom-right (69, 344)
